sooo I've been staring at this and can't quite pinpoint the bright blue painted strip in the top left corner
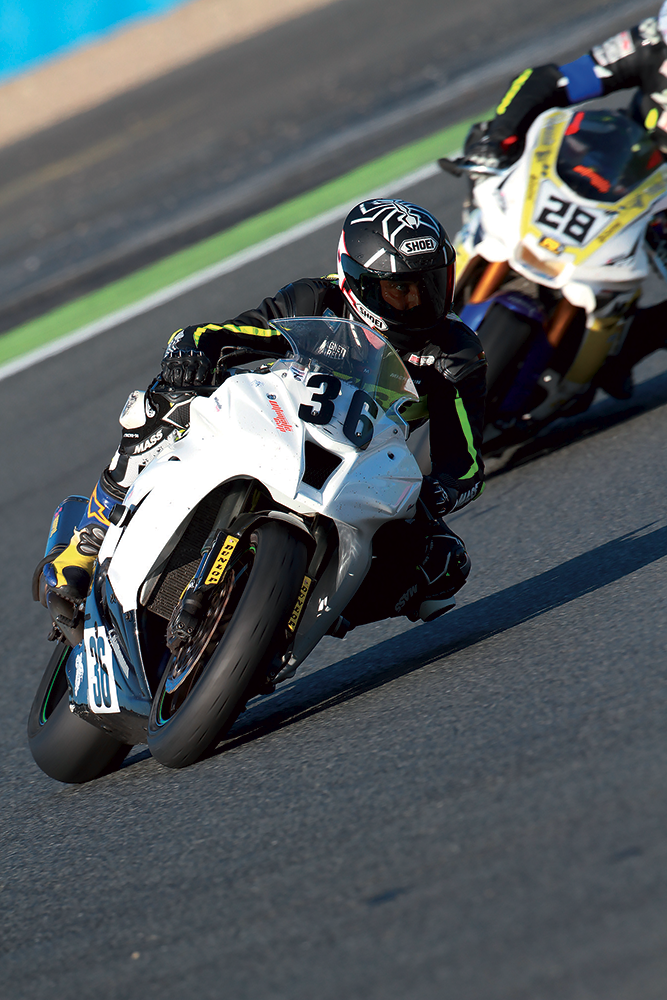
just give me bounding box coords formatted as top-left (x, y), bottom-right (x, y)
top-left (0, 0), bottom-right (185, 78)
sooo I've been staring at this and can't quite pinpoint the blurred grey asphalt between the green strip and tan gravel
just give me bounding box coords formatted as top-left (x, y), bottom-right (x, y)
top-left (0, 0), bottom-right (659, 331)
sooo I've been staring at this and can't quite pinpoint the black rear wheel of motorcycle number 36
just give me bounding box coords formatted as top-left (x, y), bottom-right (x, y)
top-left (28, 642), bottom-right (132, 784)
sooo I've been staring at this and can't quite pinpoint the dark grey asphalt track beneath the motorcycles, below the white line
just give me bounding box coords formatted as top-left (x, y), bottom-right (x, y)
top-left (0, 152), bottom-right (667, 1000)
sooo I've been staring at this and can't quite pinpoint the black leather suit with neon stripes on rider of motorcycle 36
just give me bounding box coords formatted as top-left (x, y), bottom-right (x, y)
top-left (108, 276), bottom-right (486, 625)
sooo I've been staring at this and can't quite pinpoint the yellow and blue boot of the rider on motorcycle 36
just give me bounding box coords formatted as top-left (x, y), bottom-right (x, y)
top-left (42, 470), bottom-right (121, 605)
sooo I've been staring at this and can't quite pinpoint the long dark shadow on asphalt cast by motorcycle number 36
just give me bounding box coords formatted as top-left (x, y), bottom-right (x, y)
top-left (211, 525), bottom-right (667, 756)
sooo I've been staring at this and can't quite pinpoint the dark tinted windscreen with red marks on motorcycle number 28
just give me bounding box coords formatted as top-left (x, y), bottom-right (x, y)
top-left (556, 111), bottom-right (664, 202)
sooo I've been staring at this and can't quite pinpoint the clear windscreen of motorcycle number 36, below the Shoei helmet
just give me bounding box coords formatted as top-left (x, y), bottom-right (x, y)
top-left (271, 316), bottom-right (419, 410)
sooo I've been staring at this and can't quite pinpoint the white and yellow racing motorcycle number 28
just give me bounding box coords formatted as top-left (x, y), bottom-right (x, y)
top-left (439, 107), bottom-right (667, 454)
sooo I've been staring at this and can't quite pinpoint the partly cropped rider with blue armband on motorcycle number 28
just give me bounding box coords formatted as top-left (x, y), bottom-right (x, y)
top-left (464, 0), bottom-right (667, 399)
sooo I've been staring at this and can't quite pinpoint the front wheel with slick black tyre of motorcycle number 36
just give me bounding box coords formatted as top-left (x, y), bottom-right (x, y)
top-left (148, 521), bottom-right (307, 767)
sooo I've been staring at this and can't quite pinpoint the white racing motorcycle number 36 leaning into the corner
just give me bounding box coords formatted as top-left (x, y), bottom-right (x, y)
top-left (28, 317), bottom-right (428, 782)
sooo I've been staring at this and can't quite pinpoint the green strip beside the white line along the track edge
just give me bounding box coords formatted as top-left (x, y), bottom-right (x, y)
top-left (0, 116), bottom-right (480, 364)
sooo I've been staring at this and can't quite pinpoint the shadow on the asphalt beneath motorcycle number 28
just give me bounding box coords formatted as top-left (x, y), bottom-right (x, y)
top-left (487, 372), bottom-right (667, 479)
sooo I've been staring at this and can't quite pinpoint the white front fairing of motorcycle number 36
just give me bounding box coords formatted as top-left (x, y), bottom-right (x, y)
top-left (100, 328), bottom-right (422, 662)
